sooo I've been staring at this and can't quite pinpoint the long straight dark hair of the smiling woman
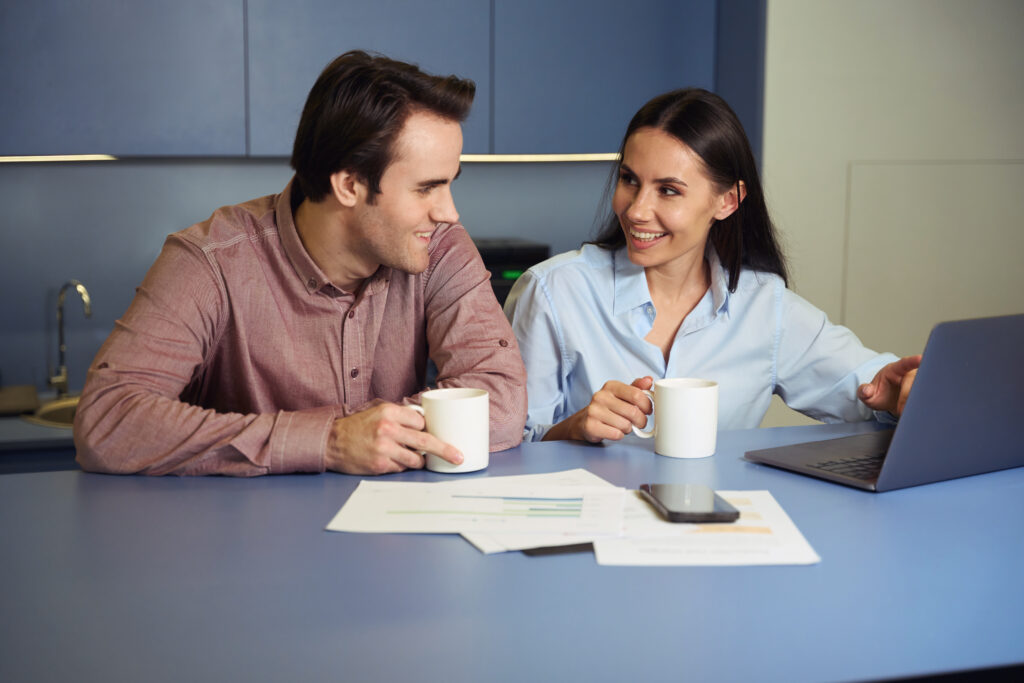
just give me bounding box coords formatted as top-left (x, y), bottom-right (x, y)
top-left (592, 88), bottom-right (787, 292)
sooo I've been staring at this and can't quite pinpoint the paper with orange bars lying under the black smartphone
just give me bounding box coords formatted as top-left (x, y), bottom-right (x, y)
top-left (594, 490), bottom-right (821, 566)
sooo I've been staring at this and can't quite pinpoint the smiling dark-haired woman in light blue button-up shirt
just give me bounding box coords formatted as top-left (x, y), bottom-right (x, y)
top-left (505, 89), bottom-right (921, 441)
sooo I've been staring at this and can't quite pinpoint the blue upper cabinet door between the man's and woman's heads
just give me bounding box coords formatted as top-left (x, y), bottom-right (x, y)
top-left (494, 0), bottom-right (717, 154)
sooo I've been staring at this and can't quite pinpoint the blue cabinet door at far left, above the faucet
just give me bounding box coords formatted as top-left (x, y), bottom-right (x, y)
top-left (0, 0), bottom-right (246, 156)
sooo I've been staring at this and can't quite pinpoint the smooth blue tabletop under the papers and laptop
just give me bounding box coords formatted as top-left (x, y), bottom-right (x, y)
top-left (0, 424), bottom-right (1024, 681)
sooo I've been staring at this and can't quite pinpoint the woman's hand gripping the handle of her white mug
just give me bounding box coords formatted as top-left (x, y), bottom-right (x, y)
top-left (544, 377), bottom-right (654, 443)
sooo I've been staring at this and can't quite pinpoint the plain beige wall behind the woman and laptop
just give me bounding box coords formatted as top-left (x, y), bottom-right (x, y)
top-left (764, 0), bottom-right (1024, 425)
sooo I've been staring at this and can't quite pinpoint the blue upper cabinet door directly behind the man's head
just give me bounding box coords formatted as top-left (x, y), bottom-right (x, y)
top-left (249, 0), bottom-right (490, 156)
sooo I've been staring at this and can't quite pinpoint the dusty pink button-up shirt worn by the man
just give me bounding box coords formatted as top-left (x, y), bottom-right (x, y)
top-left (75, 183), bottom-right (526, 475)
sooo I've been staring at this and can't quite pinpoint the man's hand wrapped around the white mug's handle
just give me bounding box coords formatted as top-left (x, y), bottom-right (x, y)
top-left (325, 403), bottom-right (462, 474)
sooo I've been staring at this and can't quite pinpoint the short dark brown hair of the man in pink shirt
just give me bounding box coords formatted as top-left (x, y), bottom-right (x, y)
top-left (292, 50), bottom-right (476, 204)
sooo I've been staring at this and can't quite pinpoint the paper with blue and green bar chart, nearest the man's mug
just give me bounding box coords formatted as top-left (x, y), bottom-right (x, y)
top-left (327, 477), bottom-right (626, 536)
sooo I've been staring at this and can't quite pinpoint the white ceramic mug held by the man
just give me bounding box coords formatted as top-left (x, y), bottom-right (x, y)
top-left (409, 387), bottom-right (490, 473)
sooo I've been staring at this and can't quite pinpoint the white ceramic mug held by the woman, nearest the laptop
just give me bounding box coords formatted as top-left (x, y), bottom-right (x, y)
top-left (633, 377), bottom-right (718, 458)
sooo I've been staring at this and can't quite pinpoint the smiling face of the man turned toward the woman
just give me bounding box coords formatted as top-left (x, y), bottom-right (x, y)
top-left (356, 112), bottom-right (462, 273)
